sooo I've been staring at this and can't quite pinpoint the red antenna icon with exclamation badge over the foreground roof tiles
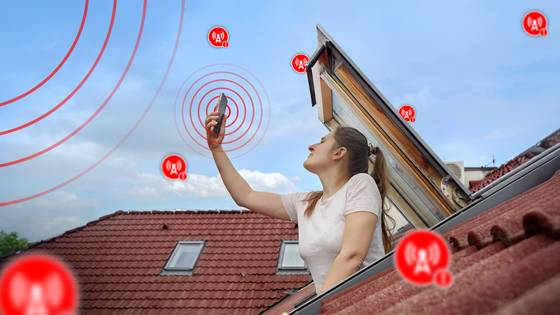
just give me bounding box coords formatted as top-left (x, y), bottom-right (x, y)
top-left (395, 230), bottom-right (451, 286)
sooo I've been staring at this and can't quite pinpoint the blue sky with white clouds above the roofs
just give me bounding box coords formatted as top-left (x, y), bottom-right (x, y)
top-left (0, 0), bottom-right (560, 241)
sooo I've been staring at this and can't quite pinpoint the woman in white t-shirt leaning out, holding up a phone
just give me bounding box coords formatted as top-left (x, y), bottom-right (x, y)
top-left (205, 112), bottom-right (394, 294)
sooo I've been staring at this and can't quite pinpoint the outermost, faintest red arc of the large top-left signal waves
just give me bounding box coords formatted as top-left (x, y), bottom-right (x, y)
top-left (0, 0), bottom-right (185, 206)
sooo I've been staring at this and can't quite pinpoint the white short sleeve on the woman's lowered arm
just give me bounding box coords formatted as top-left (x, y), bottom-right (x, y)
top-left (344, 173), bottom-right (381, 217)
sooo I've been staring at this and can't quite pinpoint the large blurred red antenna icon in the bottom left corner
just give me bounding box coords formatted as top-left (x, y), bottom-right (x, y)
top-left (0, 255), bottom-right (78, 315)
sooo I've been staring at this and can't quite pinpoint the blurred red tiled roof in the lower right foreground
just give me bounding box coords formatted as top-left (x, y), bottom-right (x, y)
top-left (321, 170), bottom-right (560, 315)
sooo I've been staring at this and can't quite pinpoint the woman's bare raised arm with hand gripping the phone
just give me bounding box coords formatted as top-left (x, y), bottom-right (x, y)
top-left (206, 112), bottom-right (290, 220)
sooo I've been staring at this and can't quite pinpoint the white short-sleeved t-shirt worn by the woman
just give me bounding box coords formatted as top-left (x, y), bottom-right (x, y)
top-left (280, 173), bottom-right (385, 293)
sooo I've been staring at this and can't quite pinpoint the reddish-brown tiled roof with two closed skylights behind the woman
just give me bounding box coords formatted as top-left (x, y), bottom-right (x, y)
top-left (1, 210), bottom-right (311, 314)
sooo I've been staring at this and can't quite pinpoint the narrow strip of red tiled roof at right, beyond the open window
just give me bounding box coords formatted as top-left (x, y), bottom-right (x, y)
top-left (469, 129), bottom-right (560, 192)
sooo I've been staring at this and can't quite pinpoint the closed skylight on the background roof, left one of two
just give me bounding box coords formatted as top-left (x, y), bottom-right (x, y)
top-left (161, 241), bottom-right (204, 275)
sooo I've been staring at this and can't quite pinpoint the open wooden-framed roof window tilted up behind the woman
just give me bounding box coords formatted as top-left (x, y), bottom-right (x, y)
top-left (307, 26), bottom-right (472, 228)
